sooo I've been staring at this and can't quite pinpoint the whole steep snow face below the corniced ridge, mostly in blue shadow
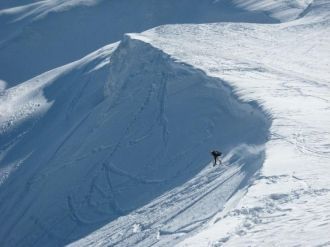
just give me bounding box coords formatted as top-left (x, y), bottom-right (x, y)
top-left (0, 36), bottom-right (269, 246)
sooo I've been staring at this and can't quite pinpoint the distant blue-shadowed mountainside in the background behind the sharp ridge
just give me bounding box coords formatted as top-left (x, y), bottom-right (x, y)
top-left (0, 0), bottom-right (276, 86)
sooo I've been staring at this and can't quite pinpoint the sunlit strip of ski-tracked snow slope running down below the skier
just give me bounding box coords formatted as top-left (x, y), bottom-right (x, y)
top-left (70, 146), bottom-right (261, 246)
